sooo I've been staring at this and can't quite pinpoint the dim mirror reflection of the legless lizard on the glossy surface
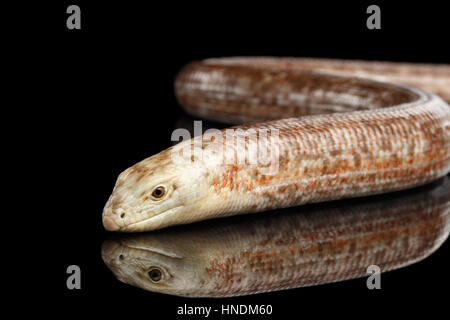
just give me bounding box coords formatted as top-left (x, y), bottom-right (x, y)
top-left (102, 177), bottom-right (450, 297)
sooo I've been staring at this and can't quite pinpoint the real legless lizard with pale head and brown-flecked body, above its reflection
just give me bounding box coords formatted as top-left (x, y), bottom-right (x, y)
top-left (103, 59), bottom-right (450, 232)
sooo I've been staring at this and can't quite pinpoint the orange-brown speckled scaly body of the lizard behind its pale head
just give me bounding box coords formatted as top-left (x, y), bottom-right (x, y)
top-left (175, 58), bottom-right (450, 220)
